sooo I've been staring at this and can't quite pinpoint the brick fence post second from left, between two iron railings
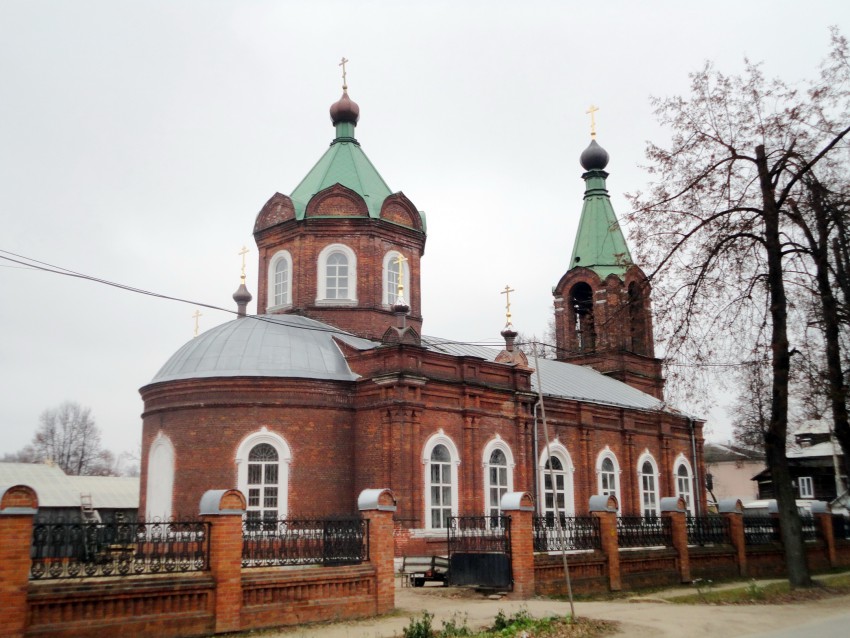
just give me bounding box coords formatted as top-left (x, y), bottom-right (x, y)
top-left (200, 490), bottom-right (246, 634)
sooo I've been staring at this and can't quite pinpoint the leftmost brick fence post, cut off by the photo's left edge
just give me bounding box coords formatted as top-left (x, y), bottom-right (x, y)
top-left (0, 485), bottom-right (38, 637)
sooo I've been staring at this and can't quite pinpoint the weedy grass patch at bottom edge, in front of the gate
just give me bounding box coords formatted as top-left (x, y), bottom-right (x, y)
top-left (402, 609), bottom-right (617, 638)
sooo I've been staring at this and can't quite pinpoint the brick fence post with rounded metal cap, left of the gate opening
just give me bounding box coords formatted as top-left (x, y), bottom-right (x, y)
top-left (357, 489), bottom-right (396, 614)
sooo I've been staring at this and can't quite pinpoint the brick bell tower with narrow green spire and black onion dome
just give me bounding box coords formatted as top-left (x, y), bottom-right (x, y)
top-left (552, 131), bottom-right (664, 399)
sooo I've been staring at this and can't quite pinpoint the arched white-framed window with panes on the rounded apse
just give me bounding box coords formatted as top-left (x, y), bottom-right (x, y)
top-left (236, 428), bottom-right (292, 524)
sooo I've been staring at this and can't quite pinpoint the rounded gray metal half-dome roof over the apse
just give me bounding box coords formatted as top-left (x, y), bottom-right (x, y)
top-left (151, 315), bottom-right (378, 383)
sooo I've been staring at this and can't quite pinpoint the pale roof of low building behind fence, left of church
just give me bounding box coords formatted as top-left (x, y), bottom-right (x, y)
top-left (0, 463), bottom-right (139, 509)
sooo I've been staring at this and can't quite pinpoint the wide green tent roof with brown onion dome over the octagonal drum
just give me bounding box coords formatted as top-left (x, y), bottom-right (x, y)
top-left (290, 92), bottom-right (392, 219)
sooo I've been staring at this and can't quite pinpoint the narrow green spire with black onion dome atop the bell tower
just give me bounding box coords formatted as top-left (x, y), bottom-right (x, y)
top-left (570, 140), bottom-right (634, 279)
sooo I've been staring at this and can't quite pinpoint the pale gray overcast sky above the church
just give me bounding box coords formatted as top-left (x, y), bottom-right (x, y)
top-left (0, 0), bottom-right (850, 460)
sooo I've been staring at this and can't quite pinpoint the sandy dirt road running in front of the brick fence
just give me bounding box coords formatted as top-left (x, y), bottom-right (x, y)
top-left (256, 587), bottom-right (850, 638)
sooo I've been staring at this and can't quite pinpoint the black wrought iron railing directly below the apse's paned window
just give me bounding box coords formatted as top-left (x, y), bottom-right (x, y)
top-left (242, 518), bottom-right (369, 567)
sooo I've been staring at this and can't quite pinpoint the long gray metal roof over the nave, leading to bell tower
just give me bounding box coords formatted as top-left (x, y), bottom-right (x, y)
top-left (422, 337), bottom-right (673, 411)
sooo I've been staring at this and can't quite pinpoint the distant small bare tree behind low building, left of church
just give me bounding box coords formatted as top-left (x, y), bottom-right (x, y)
top-left (32, 401), bottom-right (114, 476)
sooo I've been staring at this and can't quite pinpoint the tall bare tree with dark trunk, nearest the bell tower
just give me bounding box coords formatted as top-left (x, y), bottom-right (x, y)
top-left (627, 31), bottom-right (850, 586)
